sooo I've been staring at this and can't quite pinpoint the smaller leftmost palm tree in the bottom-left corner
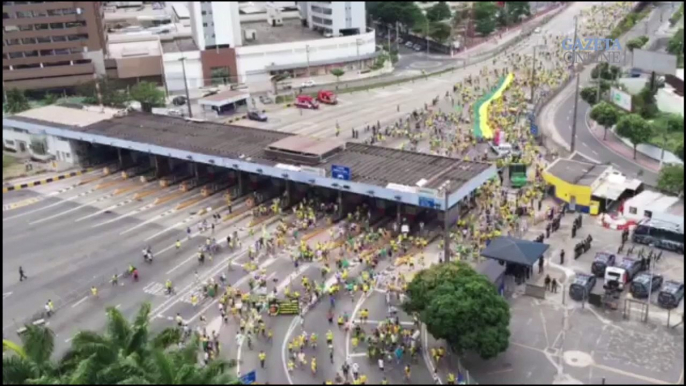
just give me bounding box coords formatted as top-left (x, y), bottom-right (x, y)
top-left (2, 325), bottom-right (57, 384)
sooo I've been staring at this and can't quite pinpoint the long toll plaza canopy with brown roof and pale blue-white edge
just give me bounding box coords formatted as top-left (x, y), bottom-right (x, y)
top-left (3, 105), bottom-right (496, 211)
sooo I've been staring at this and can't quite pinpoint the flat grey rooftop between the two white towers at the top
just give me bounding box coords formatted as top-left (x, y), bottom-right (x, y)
top-left (241, 19), bottom-right (324, 46)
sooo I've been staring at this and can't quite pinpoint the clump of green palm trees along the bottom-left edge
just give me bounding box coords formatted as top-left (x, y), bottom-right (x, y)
top-left (2, 303), bottom-right (238, 385)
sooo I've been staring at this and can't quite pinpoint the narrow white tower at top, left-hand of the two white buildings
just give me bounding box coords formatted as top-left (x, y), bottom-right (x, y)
top-left (188, 1), bottom-right (241, 51)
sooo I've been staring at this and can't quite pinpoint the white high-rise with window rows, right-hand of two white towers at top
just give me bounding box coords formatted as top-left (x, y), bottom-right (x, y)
top-left (298, 1), bottom-right (367, 37)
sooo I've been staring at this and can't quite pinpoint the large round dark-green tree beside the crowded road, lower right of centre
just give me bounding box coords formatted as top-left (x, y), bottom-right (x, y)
top-left (403, 262), bottom-right (510, 359)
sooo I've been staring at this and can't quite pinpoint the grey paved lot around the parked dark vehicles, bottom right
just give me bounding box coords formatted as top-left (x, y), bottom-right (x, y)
top-left (464, 207), bottom-right (684, 384)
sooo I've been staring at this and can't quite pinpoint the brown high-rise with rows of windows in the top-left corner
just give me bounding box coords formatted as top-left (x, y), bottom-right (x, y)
top-left (2, 1), bottom-right (105, 90)
